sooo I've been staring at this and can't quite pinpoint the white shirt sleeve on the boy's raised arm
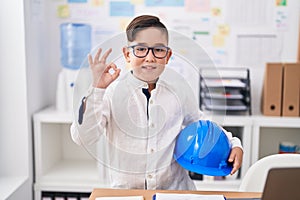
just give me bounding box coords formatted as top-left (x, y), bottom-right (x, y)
top-left (70, 87), bottom-right (110, 145)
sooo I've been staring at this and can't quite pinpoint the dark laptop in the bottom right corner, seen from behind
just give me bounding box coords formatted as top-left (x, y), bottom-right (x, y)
top-left (227, 167), bottom-right (300, 200)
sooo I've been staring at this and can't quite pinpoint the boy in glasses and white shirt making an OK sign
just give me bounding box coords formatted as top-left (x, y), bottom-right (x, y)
top-left (71, 15), bottom-right (243, 190)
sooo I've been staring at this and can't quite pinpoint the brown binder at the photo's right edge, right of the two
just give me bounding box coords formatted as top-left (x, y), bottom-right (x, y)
top-left (282, 63), bottom-right (300, 117)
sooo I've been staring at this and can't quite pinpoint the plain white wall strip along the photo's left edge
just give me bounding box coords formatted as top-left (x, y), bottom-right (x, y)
top-left (0, 0), bottom-right (32, 199)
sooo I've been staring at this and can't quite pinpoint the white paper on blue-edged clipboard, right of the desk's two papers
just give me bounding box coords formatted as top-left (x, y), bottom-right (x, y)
top-left (155, 193), bottom-right (225, 200)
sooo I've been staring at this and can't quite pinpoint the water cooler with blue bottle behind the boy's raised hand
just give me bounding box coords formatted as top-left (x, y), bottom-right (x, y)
top-left (56, 23), bottom-right (91, 112)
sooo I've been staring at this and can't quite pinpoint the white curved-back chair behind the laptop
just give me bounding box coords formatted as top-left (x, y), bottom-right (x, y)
top-left (239, 154), bottom-right (300, 192)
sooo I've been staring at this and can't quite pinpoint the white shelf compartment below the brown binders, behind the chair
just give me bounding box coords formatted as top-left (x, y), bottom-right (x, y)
top-left (251, 116), bottom-right (300, 164)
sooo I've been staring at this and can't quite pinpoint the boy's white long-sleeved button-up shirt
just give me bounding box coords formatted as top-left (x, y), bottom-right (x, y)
top-left (71, 70), bottom-right (241, 190)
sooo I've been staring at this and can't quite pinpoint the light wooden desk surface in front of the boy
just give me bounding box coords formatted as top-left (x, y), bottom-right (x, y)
top-left (89, 188), bottom-right (261, 200)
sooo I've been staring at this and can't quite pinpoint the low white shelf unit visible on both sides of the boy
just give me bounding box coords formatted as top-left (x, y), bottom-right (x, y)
top-left (34, 108), bottom-right (300, 196)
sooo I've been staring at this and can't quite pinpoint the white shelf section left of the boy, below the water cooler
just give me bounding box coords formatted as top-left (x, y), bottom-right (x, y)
top-left (34, 108), bottom-right (103, 200)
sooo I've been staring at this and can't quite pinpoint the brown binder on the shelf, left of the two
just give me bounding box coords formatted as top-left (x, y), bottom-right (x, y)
top-left (262, 63), bottom-right (283, 116)
